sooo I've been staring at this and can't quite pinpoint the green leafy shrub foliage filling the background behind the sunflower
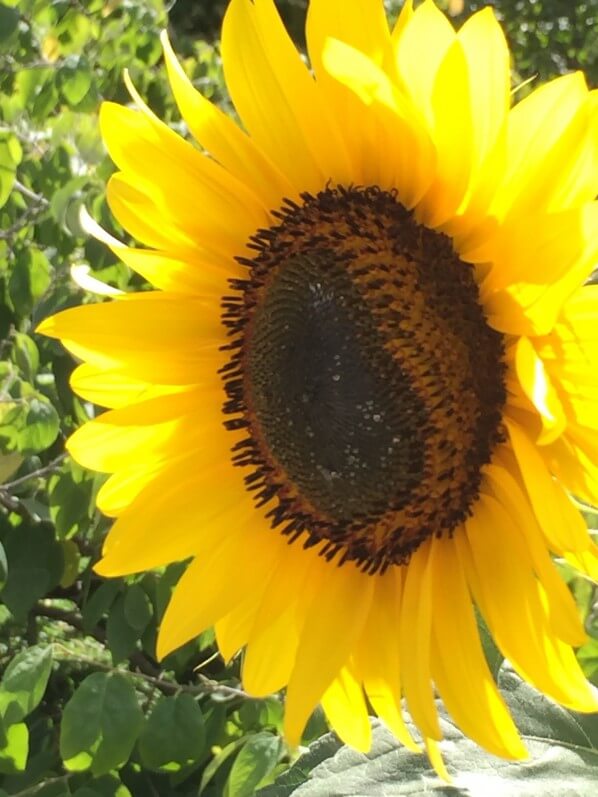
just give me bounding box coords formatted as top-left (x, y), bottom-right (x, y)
top-left (0, 0), bottom-right (598, 797)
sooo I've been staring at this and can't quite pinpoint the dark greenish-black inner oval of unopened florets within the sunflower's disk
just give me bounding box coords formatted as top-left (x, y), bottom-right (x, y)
top-left (246, 251), bottom-right (425, 522)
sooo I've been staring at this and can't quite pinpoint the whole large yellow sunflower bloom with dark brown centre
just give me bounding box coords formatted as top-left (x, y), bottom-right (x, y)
top-left (40, 0), bottom-right (598, 772)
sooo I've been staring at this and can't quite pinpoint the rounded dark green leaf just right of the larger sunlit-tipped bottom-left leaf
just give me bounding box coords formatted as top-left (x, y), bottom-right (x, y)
top-left (139, 693), bottom-right (205, 772)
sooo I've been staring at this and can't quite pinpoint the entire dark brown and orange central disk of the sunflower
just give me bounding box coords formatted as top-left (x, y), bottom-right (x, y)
top-left (223, 188), bottom-right (506, 573)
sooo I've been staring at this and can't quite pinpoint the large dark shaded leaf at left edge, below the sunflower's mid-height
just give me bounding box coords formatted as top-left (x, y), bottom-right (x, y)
top-left (2, 523), bottom-right (63, 622)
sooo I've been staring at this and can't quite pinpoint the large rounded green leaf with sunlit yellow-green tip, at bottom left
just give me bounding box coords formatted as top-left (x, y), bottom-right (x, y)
top-left (60, 672), bottom-right (143, 775)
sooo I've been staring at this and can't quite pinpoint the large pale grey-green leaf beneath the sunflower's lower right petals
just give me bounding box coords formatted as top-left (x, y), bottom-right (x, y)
top-left (257, 671), bottom-right (598, 797)
